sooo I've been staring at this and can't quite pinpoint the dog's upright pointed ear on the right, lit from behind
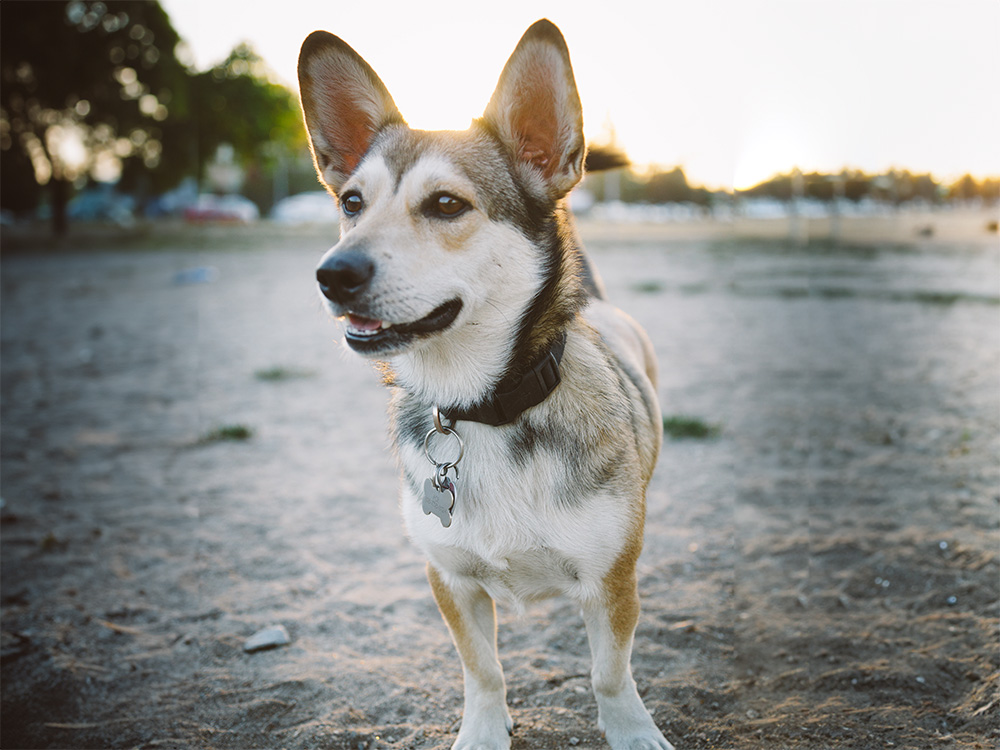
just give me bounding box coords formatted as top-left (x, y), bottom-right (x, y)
top-left (483, 19), bottom-right (586, 200)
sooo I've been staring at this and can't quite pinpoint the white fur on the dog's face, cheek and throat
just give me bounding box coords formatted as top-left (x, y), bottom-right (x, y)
top-left (344, 155), bottom-right (540, 412)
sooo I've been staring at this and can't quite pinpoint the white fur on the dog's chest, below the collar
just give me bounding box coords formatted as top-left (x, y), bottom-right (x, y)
top-left (401, 435), bottom-right (625, 605)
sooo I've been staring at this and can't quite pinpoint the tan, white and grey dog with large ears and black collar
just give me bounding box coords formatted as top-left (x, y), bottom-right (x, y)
top-left (298, 19), bottom-right (671, 750)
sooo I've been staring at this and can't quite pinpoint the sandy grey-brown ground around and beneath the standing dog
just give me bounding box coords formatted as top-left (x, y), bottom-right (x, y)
top-left (0, 213), bottom-right (1000, 750)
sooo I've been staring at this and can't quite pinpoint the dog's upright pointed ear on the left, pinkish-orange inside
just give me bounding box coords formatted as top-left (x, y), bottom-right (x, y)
top-left (299, 31), bottom-right (406, 193)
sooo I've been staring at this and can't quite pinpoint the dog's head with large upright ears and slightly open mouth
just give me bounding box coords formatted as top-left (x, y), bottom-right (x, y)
top-left (299, 20), bottom-right (585, 368)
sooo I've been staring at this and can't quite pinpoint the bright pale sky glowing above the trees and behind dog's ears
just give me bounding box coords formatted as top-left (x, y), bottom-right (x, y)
top-left (161, 0), bottom-right (1000, 188)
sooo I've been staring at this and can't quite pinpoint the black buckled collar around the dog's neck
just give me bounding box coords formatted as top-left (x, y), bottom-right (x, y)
top-left (442, 332), bottom-right (566, 427)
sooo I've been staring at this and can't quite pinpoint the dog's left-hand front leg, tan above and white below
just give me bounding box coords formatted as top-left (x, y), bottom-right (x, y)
top-left (427, 564), bottom-right (513, 750)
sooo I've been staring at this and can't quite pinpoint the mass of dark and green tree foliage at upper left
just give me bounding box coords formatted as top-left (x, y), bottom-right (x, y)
top-left (0, 0), bottom-right (305, 231)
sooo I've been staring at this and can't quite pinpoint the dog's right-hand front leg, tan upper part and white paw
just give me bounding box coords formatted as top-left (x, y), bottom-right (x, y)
top-left (583, 560), bottom-right (673, 750)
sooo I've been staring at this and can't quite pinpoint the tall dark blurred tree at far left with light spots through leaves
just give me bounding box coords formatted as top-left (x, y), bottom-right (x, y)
top-left (0, 0), bottom-right (189, 234)
